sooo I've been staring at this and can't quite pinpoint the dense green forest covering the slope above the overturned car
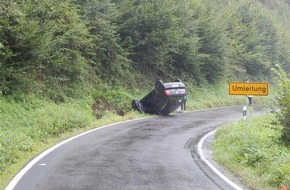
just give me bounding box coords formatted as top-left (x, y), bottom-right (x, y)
top-left (0, 0), bottom-right (290, 101)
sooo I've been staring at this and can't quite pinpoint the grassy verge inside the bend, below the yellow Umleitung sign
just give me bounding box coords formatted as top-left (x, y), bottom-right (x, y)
top-left (213, 114), bottom-right (290, 190)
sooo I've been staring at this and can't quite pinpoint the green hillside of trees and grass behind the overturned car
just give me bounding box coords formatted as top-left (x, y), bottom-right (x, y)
top-left (0, 0), bottom-right (290, 188)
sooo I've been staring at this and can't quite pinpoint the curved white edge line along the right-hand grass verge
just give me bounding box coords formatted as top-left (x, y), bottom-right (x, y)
top-left (197, 130), bottom-right (243, 190)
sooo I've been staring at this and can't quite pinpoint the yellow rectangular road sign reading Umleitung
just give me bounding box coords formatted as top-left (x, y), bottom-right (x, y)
top-left (229, 82), bottom-right (268, 96)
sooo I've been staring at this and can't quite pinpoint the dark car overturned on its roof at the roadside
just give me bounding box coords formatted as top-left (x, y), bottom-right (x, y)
top-left (132, 80), bottom-right (186, 115)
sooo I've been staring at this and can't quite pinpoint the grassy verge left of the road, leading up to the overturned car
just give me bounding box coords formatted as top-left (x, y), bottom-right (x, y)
top-left (0, 94), bottom-right (144, 189)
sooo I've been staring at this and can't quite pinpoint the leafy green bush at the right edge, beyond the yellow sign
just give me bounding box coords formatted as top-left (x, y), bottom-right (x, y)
top-left (272, 65), bottom-right (290, 143)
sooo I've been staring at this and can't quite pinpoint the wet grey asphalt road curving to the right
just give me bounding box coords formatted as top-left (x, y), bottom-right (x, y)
top-left (8, 106), bottom-right (268, 190)
